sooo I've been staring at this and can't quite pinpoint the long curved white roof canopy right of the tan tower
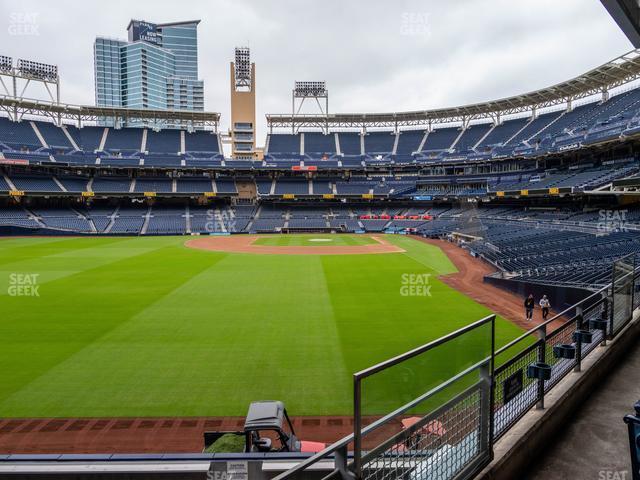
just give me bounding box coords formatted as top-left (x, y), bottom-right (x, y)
top-left (266, 49), bottom-right (640, 130)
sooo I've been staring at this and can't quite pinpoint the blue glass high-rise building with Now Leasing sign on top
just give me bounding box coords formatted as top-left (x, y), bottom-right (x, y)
top-left (94, 20), bottom-right (204, 127)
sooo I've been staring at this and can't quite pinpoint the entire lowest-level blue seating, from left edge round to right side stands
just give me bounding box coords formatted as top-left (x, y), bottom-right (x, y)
top-left (5, 200), bottom-right (640, 288)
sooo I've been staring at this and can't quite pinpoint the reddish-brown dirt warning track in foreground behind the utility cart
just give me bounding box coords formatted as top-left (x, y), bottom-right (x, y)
top-left (0, 416), bottom-right (402, 455)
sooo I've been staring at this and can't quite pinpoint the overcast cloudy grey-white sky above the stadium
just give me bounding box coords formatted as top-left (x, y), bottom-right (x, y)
top-left (0, 0), bottom-right (632, 143)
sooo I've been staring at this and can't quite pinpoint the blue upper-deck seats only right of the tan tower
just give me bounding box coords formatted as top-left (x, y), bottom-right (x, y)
top-left (269, 88), bottom-right (640, 160)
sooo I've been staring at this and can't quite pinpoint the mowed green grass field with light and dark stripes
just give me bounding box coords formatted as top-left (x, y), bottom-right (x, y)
top-left (0, 235), bottom-right (521, 417)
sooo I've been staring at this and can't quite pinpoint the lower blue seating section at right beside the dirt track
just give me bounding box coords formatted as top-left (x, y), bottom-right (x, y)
top-left (417, 207), bottom-right (640, 288)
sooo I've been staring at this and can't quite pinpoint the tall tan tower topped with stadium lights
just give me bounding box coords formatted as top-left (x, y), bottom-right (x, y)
top-left (229, 47), bottom-right (259, 159)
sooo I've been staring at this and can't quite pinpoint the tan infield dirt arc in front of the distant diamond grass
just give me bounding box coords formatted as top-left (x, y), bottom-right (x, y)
top-left (185, 235), bottom-right (405, 255)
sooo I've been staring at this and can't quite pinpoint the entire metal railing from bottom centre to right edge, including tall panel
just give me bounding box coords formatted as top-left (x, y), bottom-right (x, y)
top-left (275, 254), bottom-right (640, 480)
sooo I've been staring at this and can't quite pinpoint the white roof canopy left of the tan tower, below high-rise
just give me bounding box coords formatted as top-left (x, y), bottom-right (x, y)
top-left (0, 95), bottom-right (220, 129)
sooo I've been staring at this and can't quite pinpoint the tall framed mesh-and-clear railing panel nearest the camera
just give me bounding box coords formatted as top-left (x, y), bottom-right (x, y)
top-left (352, 315), bottom-right (495, 480)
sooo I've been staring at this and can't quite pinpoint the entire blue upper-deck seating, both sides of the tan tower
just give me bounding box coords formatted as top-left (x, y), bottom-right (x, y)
top-left (0, 87), bottom-right (640, 170)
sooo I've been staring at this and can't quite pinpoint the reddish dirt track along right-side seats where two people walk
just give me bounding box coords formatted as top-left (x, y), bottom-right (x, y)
top-left (414, 237), bottom-right (563, 332)
